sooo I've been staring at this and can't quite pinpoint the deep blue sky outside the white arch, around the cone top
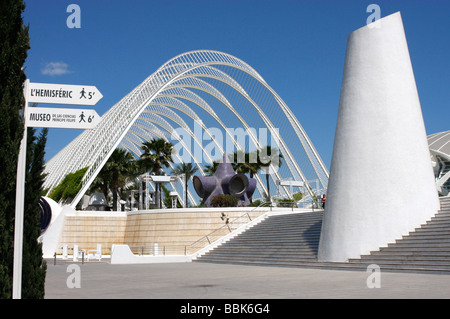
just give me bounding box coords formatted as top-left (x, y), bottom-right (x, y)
top-left (24, 0), bottom-right (450, 168)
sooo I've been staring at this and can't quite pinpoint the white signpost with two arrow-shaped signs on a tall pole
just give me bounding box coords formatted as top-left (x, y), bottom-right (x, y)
top-left (12, 79), bottom-right (103, 299)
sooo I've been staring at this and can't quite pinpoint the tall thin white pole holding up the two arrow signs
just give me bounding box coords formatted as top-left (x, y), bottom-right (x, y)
top-left (12, 79), bottom-right (30, 299)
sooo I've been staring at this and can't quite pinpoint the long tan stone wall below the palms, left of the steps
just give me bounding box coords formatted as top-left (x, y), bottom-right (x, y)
top-left (48, 207), bottom-right (268, 258)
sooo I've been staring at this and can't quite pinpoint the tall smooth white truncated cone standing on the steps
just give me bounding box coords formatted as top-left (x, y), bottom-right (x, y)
top-left (318, 13), bottom-right (439, 261)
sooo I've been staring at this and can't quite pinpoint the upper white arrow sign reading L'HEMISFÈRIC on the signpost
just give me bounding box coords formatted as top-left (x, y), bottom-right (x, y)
top-left (28, 82), bottom-right (103, 106)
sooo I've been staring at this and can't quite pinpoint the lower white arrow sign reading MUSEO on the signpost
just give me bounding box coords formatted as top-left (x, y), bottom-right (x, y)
top-left (27, 107), bottom-right (101, 129)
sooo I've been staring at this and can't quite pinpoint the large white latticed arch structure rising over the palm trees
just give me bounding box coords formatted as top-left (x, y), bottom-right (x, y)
top-left (44, 50), bottom-right (329, 207)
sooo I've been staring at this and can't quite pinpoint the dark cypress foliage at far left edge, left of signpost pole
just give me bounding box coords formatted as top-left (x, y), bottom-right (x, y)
top-left (0, 0), bottom-right (30, 298)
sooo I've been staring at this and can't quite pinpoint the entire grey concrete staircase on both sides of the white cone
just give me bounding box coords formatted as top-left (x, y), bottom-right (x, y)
top-left (197, 198), bottom-right (450, 272)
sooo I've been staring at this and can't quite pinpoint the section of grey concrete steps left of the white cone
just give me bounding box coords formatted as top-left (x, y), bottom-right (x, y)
top-left (197, 211), bottom-right (323, 266)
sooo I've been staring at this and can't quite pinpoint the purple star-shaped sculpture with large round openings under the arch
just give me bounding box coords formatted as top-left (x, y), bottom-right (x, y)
top-left (193, 155), bottom-right (256, 207)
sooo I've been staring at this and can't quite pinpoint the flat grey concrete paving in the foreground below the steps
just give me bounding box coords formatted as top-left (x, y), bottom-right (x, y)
top-left (45, 260), bottom-right (450, 300)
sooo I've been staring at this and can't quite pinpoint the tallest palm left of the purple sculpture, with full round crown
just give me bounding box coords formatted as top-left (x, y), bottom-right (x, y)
top-left (140, 138), bottom-right (173, 208)
